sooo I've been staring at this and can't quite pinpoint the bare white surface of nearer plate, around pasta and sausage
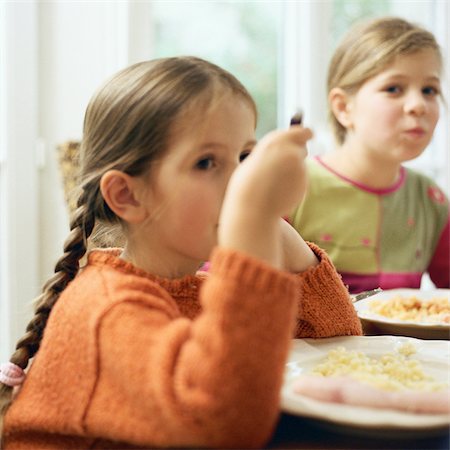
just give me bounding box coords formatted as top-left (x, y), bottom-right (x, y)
top-left (281, 336), bottom-right (450, 435)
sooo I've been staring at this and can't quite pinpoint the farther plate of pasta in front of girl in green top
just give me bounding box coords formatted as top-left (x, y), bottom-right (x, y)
top-left (355, 289), bottom-right (450, 340)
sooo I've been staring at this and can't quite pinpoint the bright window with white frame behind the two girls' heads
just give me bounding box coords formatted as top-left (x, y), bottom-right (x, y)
top-left (148, 0), bottom-right (449, 195)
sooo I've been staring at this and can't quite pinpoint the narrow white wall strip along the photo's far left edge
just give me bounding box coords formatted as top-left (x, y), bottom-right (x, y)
top-left (0, 3), bottom-right (39, 360)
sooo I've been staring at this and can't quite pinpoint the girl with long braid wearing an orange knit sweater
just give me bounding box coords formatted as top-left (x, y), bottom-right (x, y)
top-left (0, 57), bottom-right (361, 450)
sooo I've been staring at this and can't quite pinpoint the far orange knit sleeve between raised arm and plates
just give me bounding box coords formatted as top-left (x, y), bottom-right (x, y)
top-left (294, 243), bottom-right (362, 338)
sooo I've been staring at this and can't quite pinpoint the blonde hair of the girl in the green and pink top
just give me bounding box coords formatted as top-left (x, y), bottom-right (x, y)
top-left (327, 17), bottom-right (443, 144)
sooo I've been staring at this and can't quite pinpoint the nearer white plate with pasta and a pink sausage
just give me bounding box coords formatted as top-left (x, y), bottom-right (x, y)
top-left (281, 336), bottom-right (450, 435)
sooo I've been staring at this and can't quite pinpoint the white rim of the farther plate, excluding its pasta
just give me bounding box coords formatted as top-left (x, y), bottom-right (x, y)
top-left (355, 289), bottom-right (450, 339)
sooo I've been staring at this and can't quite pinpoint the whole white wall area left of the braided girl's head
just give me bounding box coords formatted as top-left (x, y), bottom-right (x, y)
top-left (0, 0), bottom-right (156, 360)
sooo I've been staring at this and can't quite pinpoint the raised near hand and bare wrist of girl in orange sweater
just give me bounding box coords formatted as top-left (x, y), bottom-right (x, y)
top-left (219, 127), bottom-right (312, 269)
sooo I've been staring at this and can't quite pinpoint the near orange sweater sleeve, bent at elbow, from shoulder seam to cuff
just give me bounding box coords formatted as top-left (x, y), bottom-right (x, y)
top-left (86, 249), bottom-right (298, 448)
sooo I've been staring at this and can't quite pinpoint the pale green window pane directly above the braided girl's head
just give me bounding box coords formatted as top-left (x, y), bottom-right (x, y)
top-left (152, 1), bottom-right (281, 135)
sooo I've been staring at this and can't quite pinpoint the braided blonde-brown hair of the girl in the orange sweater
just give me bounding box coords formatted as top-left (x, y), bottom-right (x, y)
top-left (0, 56), bottom-right (256, 436)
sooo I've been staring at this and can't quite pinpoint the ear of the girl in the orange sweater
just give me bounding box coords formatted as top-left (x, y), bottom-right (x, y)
top-left (100, 170), bottom-right (146, 223)
